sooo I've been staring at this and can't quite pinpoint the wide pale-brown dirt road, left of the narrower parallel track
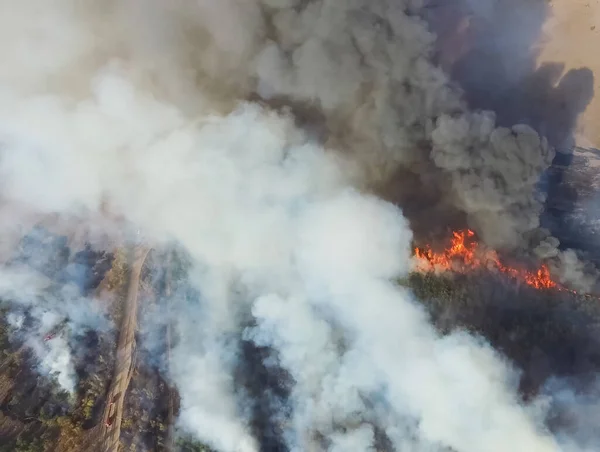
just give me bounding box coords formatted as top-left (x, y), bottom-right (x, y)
top-left (102, 246), bottom-right (150, 452)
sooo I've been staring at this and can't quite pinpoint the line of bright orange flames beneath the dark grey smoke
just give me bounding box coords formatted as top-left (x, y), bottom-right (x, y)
top-left (415, 230), bottom-right (560, 289)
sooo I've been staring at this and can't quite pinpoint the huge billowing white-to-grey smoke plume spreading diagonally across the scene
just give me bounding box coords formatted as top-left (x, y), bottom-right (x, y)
top-left (0, 0), bottom-right (592, 452)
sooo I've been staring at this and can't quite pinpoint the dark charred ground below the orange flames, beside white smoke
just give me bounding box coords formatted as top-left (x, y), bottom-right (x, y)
top-left (410, 271), bottom-right (600, 450)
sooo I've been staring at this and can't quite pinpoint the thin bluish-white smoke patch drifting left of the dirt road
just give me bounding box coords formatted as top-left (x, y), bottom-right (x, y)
top-left (0, 226), bottom-right (111, 393)
